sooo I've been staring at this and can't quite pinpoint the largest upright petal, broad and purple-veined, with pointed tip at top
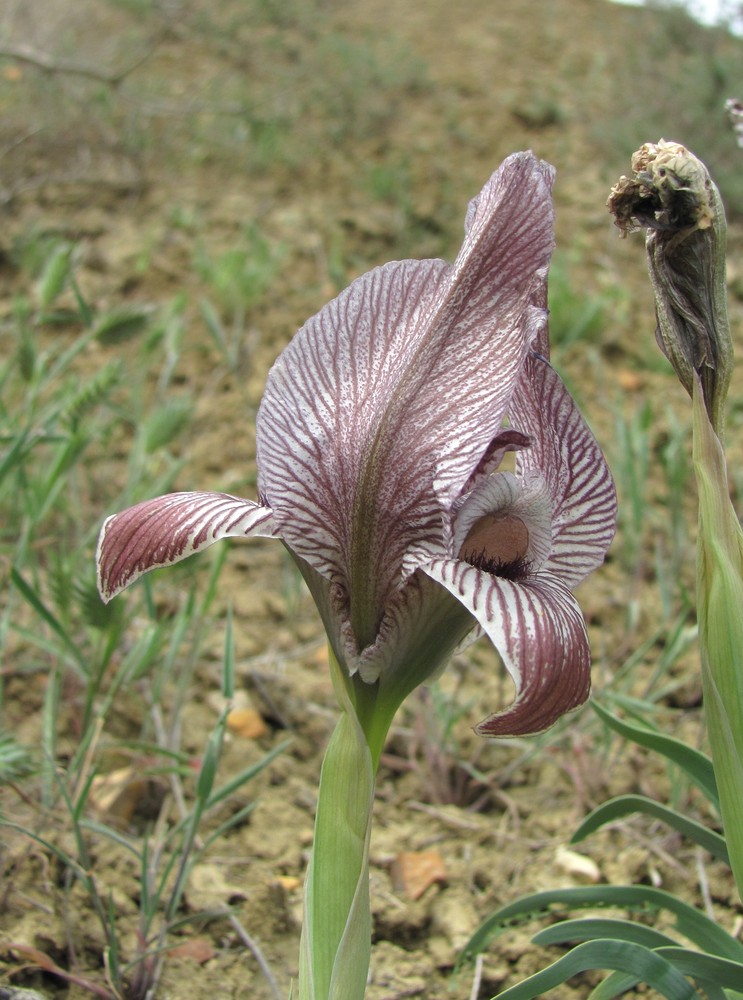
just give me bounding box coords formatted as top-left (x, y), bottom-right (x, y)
top-left (257, 153), bottom-right (553, 648)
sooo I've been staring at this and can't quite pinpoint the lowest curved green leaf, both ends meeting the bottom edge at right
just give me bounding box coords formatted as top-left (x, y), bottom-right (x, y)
top-left (498, 938), bottom-right (703, 1000)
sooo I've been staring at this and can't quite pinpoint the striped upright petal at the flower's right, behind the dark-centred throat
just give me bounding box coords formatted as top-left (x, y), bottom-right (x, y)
top-left (509, 355), bottom-right (617, 588)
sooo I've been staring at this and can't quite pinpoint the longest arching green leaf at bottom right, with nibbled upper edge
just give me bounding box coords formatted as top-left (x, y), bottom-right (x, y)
top-left (458, 885), bottom-right (743, 964)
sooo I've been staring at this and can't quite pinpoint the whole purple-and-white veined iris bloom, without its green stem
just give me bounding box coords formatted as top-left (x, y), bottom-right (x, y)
top-left (98, 153), bottom-right (616, 736)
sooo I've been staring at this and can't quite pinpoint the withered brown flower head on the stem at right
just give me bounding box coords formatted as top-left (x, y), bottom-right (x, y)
top-left (608, 139), bottom-right (732, 434)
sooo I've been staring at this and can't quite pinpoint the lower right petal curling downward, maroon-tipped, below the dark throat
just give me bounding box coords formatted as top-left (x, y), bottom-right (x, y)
top-left (423, 559), bottom-right (591, 736)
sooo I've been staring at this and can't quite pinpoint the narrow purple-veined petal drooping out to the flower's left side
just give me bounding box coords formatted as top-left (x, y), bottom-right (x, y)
top-left (97, 493), bottom-right (277, 602)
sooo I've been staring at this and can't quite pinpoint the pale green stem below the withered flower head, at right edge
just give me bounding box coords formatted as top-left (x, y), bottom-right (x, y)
top-left (693, 379), bottom-right (743, 899)
